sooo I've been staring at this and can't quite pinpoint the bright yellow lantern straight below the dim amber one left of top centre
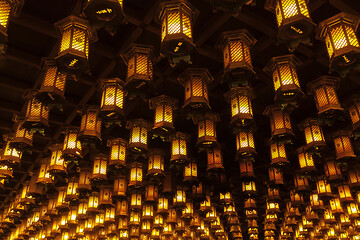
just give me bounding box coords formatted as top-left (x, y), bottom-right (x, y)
top-left (127, 119), bottom-right (150, 152)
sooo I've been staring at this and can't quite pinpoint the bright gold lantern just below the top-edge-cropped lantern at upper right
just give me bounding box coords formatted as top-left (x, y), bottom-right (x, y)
top-left (264, 55), bottom-right (304, 105)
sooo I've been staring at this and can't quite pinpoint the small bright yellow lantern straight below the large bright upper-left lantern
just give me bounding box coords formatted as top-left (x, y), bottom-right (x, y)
top-left (62, 128), bottom-right (82, 160)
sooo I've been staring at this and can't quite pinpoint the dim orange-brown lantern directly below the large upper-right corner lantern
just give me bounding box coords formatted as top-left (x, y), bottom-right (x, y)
top-left (307, 76), bottom-right (343, 116)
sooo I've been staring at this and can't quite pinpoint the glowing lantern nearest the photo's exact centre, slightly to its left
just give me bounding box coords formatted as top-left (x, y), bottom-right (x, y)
top-left (149, 95), bottom-right (178, 133)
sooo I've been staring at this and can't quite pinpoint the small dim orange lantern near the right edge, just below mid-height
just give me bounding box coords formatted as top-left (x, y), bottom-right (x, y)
top-left (334, 131), bottom-right (355, 160)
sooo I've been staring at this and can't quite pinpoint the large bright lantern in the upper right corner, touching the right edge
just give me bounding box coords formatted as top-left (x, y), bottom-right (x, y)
top-left (318, 13), bottom-right (360, 70)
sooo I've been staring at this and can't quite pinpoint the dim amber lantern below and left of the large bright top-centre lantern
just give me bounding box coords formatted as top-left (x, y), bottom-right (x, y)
top-left (121, 45), bottom-right (155, 93)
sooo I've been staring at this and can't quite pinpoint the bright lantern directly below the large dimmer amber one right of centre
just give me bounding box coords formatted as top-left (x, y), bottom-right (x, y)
top-left (225, 87), bottom-right (255, 127)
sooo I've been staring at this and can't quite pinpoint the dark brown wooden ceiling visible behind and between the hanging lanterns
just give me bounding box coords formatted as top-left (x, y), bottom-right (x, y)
top-left (0, 0), bottom-right (360, 238)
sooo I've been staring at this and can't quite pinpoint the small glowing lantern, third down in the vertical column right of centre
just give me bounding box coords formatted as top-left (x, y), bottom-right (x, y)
top-left (236, 130), bottom-right (256, 157)
